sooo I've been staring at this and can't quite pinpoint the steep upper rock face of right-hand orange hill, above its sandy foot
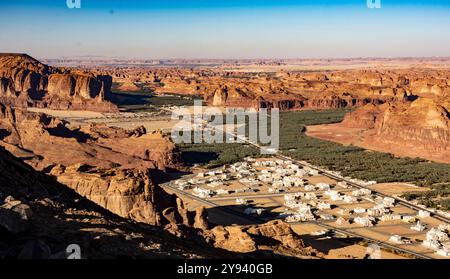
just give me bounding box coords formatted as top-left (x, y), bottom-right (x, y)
top-left (342, 97), bottom-right (450, 152)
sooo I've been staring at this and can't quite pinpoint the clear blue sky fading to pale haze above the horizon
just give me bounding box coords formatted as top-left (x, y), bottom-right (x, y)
top-left (0, 0), bottom-right (450, 59)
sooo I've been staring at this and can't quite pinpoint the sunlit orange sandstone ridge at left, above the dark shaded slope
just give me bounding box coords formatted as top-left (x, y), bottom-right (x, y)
top-left (0, 105), bottom-right (320, 257)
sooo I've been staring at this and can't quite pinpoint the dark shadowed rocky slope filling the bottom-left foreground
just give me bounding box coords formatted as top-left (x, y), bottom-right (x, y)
top-left (0, 147), bottom-right (253, 259)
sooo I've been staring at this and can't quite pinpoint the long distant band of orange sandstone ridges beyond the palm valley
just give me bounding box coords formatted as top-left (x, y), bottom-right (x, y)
top-left (95, 68), bottom-right (450, 110)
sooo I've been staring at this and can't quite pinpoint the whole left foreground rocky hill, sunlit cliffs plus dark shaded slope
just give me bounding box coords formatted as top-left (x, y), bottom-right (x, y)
top-left (0, 105), bottom-right (323, 258)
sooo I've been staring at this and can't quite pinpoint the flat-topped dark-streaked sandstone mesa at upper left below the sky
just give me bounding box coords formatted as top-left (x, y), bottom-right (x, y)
top-left (0, 54), bottom-right (118, 112)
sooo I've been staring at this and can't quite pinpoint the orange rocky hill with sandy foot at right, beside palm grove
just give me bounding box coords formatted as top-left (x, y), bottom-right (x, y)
top-left (307, 97), bottom-right (450, 163)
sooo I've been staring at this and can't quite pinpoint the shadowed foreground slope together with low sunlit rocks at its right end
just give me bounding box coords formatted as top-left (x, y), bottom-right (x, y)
top-left (0, 147), bottom-right (323, 259)
